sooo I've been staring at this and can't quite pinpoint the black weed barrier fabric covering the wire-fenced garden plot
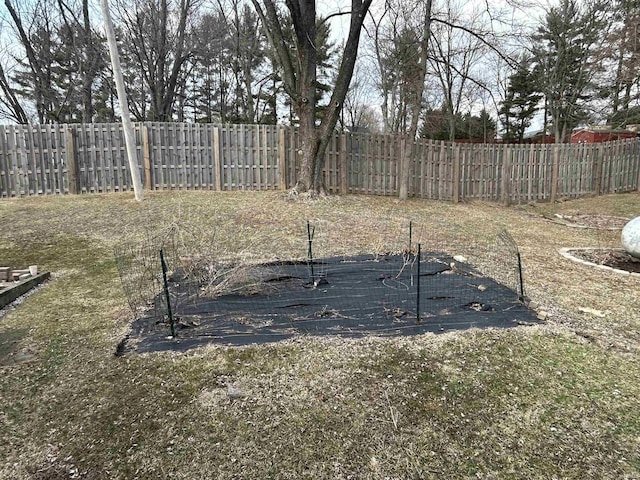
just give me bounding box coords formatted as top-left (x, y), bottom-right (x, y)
top-left (119, 252), bottom-right (538, 353)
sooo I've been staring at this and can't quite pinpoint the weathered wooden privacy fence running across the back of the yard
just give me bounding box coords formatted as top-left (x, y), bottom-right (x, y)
top-left (0, 123), bottom-right (640, 203)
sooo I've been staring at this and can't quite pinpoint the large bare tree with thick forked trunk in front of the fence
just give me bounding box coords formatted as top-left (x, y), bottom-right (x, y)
top-left (252, 0), bottom-right (372, 196)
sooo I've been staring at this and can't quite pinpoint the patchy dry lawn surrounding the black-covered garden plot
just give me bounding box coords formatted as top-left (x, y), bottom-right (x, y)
top-left (0, 192), bottom-right (640, 480)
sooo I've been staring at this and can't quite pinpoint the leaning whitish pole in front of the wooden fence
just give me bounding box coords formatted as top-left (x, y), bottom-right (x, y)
top-left (100, 0), bottom-right (144, 201)
